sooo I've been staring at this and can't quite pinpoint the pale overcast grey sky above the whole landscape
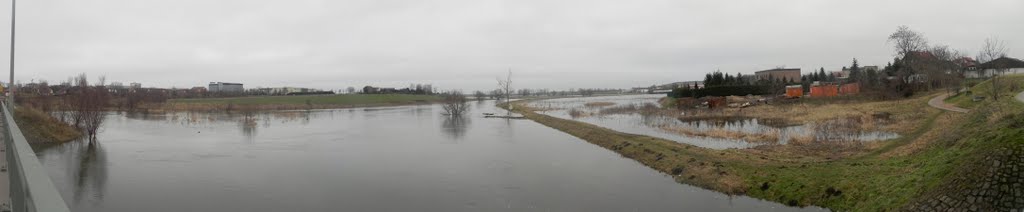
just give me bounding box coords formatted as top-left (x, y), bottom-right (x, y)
top-left (0, 0), bottom-right (1024, 91)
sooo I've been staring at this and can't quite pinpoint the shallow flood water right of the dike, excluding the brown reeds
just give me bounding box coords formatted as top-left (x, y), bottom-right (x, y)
top-left (530, 94), bottom-right (899, 150)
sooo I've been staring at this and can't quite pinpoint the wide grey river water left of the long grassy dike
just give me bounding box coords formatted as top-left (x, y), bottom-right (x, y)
top-left (38, 101), bottom-right (820, 211)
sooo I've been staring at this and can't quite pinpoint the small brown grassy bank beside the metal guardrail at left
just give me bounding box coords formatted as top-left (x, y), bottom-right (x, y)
top-left (14, 107), bottom-right (82, 144)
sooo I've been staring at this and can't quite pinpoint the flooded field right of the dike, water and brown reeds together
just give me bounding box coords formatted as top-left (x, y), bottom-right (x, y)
top-left (529, 94), bottom-right (898, 149)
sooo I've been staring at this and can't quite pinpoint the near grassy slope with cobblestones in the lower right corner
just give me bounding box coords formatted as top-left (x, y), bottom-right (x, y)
top-left (904, 93), bottom-right (1024, 211)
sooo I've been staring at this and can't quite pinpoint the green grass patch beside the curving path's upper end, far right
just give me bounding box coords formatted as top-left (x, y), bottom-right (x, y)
top-left (945, 75), bottom-right (1024, 109)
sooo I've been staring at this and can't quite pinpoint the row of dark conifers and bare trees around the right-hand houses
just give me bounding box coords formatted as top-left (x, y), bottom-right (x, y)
top-left (670, 26), bottom-right (1007, 98)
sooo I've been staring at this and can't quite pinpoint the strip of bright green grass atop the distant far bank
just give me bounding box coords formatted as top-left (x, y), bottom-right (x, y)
top-left (169, 94), bottom-right (440, 105)
